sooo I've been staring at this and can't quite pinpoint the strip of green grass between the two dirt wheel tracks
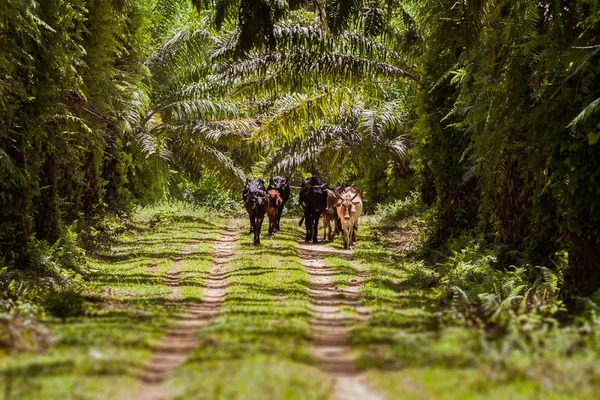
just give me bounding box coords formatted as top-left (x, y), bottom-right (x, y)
top-left (169, 221), bottom-right (331, 400)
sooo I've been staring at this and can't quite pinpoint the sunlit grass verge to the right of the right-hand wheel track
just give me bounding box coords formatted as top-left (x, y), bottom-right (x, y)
top-left (350, 224), bottom-right (600, 399)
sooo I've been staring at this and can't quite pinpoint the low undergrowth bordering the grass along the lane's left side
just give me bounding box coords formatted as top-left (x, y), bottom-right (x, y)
top-left (0, 201), bottom-right (220, 351)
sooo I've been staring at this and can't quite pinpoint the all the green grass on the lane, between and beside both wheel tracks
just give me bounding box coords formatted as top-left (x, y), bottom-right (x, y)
top-left (0, 206), bottom-right (600, 400)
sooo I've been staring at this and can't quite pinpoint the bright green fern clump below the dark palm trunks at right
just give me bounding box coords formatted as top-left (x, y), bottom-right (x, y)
top-left (438, 242), bottom-right (564, 333)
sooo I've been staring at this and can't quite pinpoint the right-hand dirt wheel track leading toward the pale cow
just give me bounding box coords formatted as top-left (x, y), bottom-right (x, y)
top-left (298, 243), bottom-right (383, 400)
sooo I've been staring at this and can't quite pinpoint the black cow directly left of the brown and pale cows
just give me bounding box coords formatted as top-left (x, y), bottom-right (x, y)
top-left (298, 176), bottom-right (327, 243)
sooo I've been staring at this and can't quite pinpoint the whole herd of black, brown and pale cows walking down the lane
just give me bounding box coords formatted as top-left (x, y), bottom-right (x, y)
top-left (242, 176), bottom-right (363, 249)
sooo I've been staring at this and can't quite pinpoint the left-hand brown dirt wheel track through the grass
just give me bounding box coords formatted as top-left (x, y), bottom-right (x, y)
top-left (136, 224), bottom-right (240, 400)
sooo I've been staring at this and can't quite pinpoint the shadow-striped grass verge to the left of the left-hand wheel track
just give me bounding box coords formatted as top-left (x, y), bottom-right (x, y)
top-left (0, 205), bottom-right (222, 400)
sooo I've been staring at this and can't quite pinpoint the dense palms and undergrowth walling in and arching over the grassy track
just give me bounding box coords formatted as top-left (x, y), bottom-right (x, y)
top-left (0, 0), bottom-right (600, 396)
